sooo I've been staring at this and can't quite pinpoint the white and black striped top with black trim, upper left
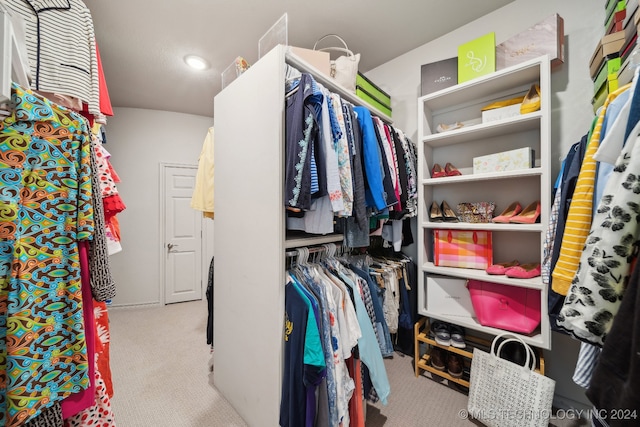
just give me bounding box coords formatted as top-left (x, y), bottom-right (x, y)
top-left (6, 0), bottom-right (100, 115)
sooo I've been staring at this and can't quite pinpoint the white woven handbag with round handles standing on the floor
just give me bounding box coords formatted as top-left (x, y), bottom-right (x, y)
top-left (467, 334), bottom-right (556, 427)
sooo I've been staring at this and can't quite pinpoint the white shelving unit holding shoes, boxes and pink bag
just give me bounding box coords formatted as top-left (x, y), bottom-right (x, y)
top-left (418, 56), bottom-right (552, 349)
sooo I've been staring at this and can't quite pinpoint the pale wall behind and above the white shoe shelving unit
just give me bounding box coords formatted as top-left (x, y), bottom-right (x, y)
top-left (366, 0), bottom-right (604, 408)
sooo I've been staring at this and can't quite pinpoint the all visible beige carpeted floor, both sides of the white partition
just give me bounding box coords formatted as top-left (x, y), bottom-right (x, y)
top-left (109, 301), bottom-right (588, 427)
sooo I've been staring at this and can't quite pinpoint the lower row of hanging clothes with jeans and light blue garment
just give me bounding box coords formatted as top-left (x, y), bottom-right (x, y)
top-left (281, 247), bottom-right (399, 426)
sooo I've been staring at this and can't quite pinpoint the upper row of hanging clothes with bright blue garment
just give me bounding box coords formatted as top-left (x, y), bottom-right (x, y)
top-left (285, 73), bottom-right (417, 250)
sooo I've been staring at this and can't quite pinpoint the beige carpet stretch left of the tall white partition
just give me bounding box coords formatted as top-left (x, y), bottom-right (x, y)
top-left (109, 301), bottom-right (246, 427)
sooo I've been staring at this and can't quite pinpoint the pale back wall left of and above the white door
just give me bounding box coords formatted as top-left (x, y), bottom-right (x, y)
top-left (105, 108), bottom-right (213, 306)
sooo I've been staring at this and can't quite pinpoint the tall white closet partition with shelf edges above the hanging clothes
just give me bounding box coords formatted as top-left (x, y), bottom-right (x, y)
top-left (214, 46), bottom-right (391, 426)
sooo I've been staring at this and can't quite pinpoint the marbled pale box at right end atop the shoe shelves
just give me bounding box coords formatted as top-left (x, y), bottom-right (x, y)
top-left (496, 13), bottom-right (564, 70)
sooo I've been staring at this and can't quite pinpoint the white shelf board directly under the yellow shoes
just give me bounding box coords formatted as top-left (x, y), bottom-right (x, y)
top-left (422, 111), bottom-right (542, 147)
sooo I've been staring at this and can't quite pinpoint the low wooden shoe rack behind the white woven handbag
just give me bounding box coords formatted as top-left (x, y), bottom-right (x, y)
top-left (413, 317), bottom-right (544, 388)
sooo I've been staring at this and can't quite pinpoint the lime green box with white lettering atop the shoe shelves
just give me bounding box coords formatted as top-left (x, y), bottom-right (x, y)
top-left (458, 32), bottom-right (496, 83)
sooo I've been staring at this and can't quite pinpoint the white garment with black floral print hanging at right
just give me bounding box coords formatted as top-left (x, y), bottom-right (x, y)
top-left (558, 107), bottom-right (640, 346)
